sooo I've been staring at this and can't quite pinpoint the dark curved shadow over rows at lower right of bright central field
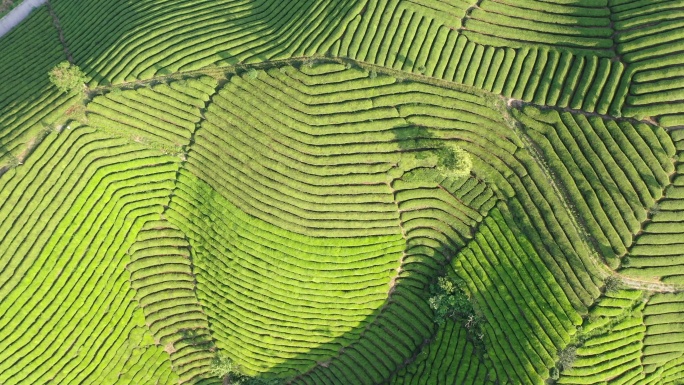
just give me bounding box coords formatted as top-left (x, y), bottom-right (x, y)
top-left (188, 178), bottom-right (492, 385)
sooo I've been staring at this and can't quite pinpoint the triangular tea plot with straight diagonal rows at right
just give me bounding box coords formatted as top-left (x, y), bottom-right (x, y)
top-left (516, 108), bottom-right (675, 260)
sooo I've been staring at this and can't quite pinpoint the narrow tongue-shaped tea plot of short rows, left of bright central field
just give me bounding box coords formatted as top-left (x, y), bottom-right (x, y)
top-left (126, 220), bottom-right (216, 383)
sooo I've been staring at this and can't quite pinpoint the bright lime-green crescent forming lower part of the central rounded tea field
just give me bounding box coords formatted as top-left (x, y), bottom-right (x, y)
top-left (165, 170), bottom-right (402, 376)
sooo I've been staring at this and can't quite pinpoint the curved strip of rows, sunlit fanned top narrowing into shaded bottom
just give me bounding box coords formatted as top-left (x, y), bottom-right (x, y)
top-left (295, 175), bottom-right (496, 384)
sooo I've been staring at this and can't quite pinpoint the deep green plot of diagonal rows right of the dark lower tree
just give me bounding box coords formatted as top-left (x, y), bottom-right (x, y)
top-left (453, 211), bottom-right (579, 382)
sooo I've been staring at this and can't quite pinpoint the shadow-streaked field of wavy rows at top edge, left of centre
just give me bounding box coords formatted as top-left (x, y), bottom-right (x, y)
top-left (53, 0), bottom-right (363, 86)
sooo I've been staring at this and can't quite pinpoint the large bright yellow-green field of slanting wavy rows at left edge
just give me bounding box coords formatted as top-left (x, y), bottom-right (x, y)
top-left (1, 128), bottom-right (182, 383)
